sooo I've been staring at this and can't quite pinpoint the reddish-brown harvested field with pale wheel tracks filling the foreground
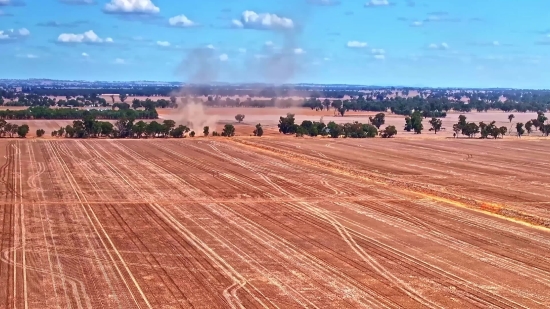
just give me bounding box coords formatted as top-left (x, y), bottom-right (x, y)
top-left (0, 137), bottom-right (550, 308)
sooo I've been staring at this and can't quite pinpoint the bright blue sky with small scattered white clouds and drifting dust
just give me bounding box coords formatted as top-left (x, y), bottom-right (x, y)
top-left (0, 0), bottom-right (550, 89)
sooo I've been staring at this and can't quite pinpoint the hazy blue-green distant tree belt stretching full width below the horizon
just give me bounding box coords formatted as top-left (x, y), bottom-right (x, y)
top-left (4, 89), bottom-right (550, 117)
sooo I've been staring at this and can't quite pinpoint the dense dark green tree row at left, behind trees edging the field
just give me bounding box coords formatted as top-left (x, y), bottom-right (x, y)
top-left (0, 106), bottom-right (158, 119)
